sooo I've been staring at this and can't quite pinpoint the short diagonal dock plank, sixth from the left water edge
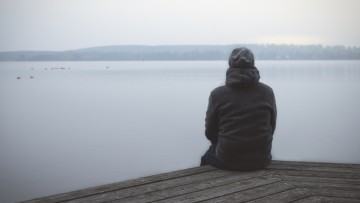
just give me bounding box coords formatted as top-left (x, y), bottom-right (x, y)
top-left (249, 188), bottom-right (311, 203)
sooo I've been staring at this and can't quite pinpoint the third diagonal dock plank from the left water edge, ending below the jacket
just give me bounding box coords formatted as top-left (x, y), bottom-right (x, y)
top-left (114, 170), bottom-right (269, 203)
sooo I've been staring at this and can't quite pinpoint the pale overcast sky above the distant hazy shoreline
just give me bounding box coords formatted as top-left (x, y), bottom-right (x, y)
top-left (0, 0), bottom-right (360, 51)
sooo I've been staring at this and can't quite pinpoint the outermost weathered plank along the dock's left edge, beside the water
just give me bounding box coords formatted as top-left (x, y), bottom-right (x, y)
top-left (25, 166), bottom-right (218, 203)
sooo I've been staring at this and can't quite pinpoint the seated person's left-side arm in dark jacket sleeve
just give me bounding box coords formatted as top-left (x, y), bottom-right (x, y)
top-left (205, 94), bottom-right (219, 144)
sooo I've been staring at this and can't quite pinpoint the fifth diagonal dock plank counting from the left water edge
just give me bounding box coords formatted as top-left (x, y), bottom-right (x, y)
top-left (200, 181), bottom-right (295, 203)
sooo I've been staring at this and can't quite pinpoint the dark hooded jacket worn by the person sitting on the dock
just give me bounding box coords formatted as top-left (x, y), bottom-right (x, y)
top-left (205, 67), bottom-right (276, 170)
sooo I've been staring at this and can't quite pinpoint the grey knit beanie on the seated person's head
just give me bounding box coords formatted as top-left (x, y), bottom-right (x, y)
top-left (229, 47), bottom-right (254, 68)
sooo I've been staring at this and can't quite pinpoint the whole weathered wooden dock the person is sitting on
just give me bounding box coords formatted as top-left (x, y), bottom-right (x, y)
top-left (26, 161), bottom-right (360, 203)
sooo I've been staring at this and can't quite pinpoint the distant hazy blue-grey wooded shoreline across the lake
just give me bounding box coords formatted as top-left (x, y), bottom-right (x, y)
top-left (0, 44), bottom-right (360, 61)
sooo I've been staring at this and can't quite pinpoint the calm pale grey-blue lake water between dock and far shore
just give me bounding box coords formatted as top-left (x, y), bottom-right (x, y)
top-left (0, 61), bottom-right (360, 202)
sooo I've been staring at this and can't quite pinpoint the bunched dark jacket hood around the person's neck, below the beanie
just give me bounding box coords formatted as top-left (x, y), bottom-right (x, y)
top-left (225, 67), bottom-right (260, 87)
